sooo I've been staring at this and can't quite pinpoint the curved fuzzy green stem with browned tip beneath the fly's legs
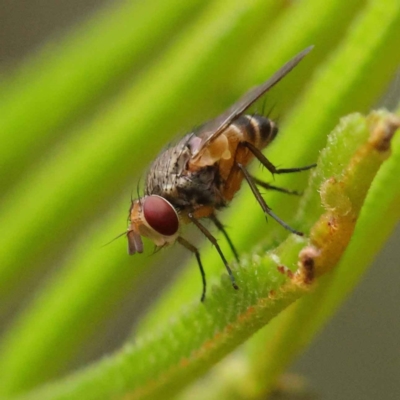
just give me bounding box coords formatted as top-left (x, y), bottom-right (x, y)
top-left (12, 114), bottom-right (400, 400)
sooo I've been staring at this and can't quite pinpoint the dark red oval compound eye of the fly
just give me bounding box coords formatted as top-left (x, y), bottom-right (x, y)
top-left (143, 195), bottom-right (179, 236)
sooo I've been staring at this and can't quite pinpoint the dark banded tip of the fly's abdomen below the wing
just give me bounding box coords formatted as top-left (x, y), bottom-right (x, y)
top-left (231, 115), bottom-right (278, 149)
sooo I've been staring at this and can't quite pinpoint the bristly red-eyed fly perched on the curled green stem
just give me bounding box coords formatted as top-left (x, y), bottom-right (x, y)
top-left (126, 46), bottom-right (315, 301)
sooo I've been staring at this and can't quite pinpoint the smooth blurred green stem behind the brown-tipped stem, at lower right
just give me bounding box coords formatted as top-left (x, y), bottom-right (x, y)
top-left (247, 112), bottom-right (400, 398)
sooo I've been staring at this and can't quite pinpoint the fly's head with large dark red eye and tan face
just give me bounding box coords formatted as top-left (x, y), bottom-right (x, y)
top-left (126, 195), bottom-right (179, 255)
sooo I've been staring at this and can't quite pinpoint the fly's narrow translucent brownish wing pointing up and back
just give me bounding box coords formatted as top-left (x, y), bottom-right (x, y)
top-left (193, 46), bottom-right (314, 158)
